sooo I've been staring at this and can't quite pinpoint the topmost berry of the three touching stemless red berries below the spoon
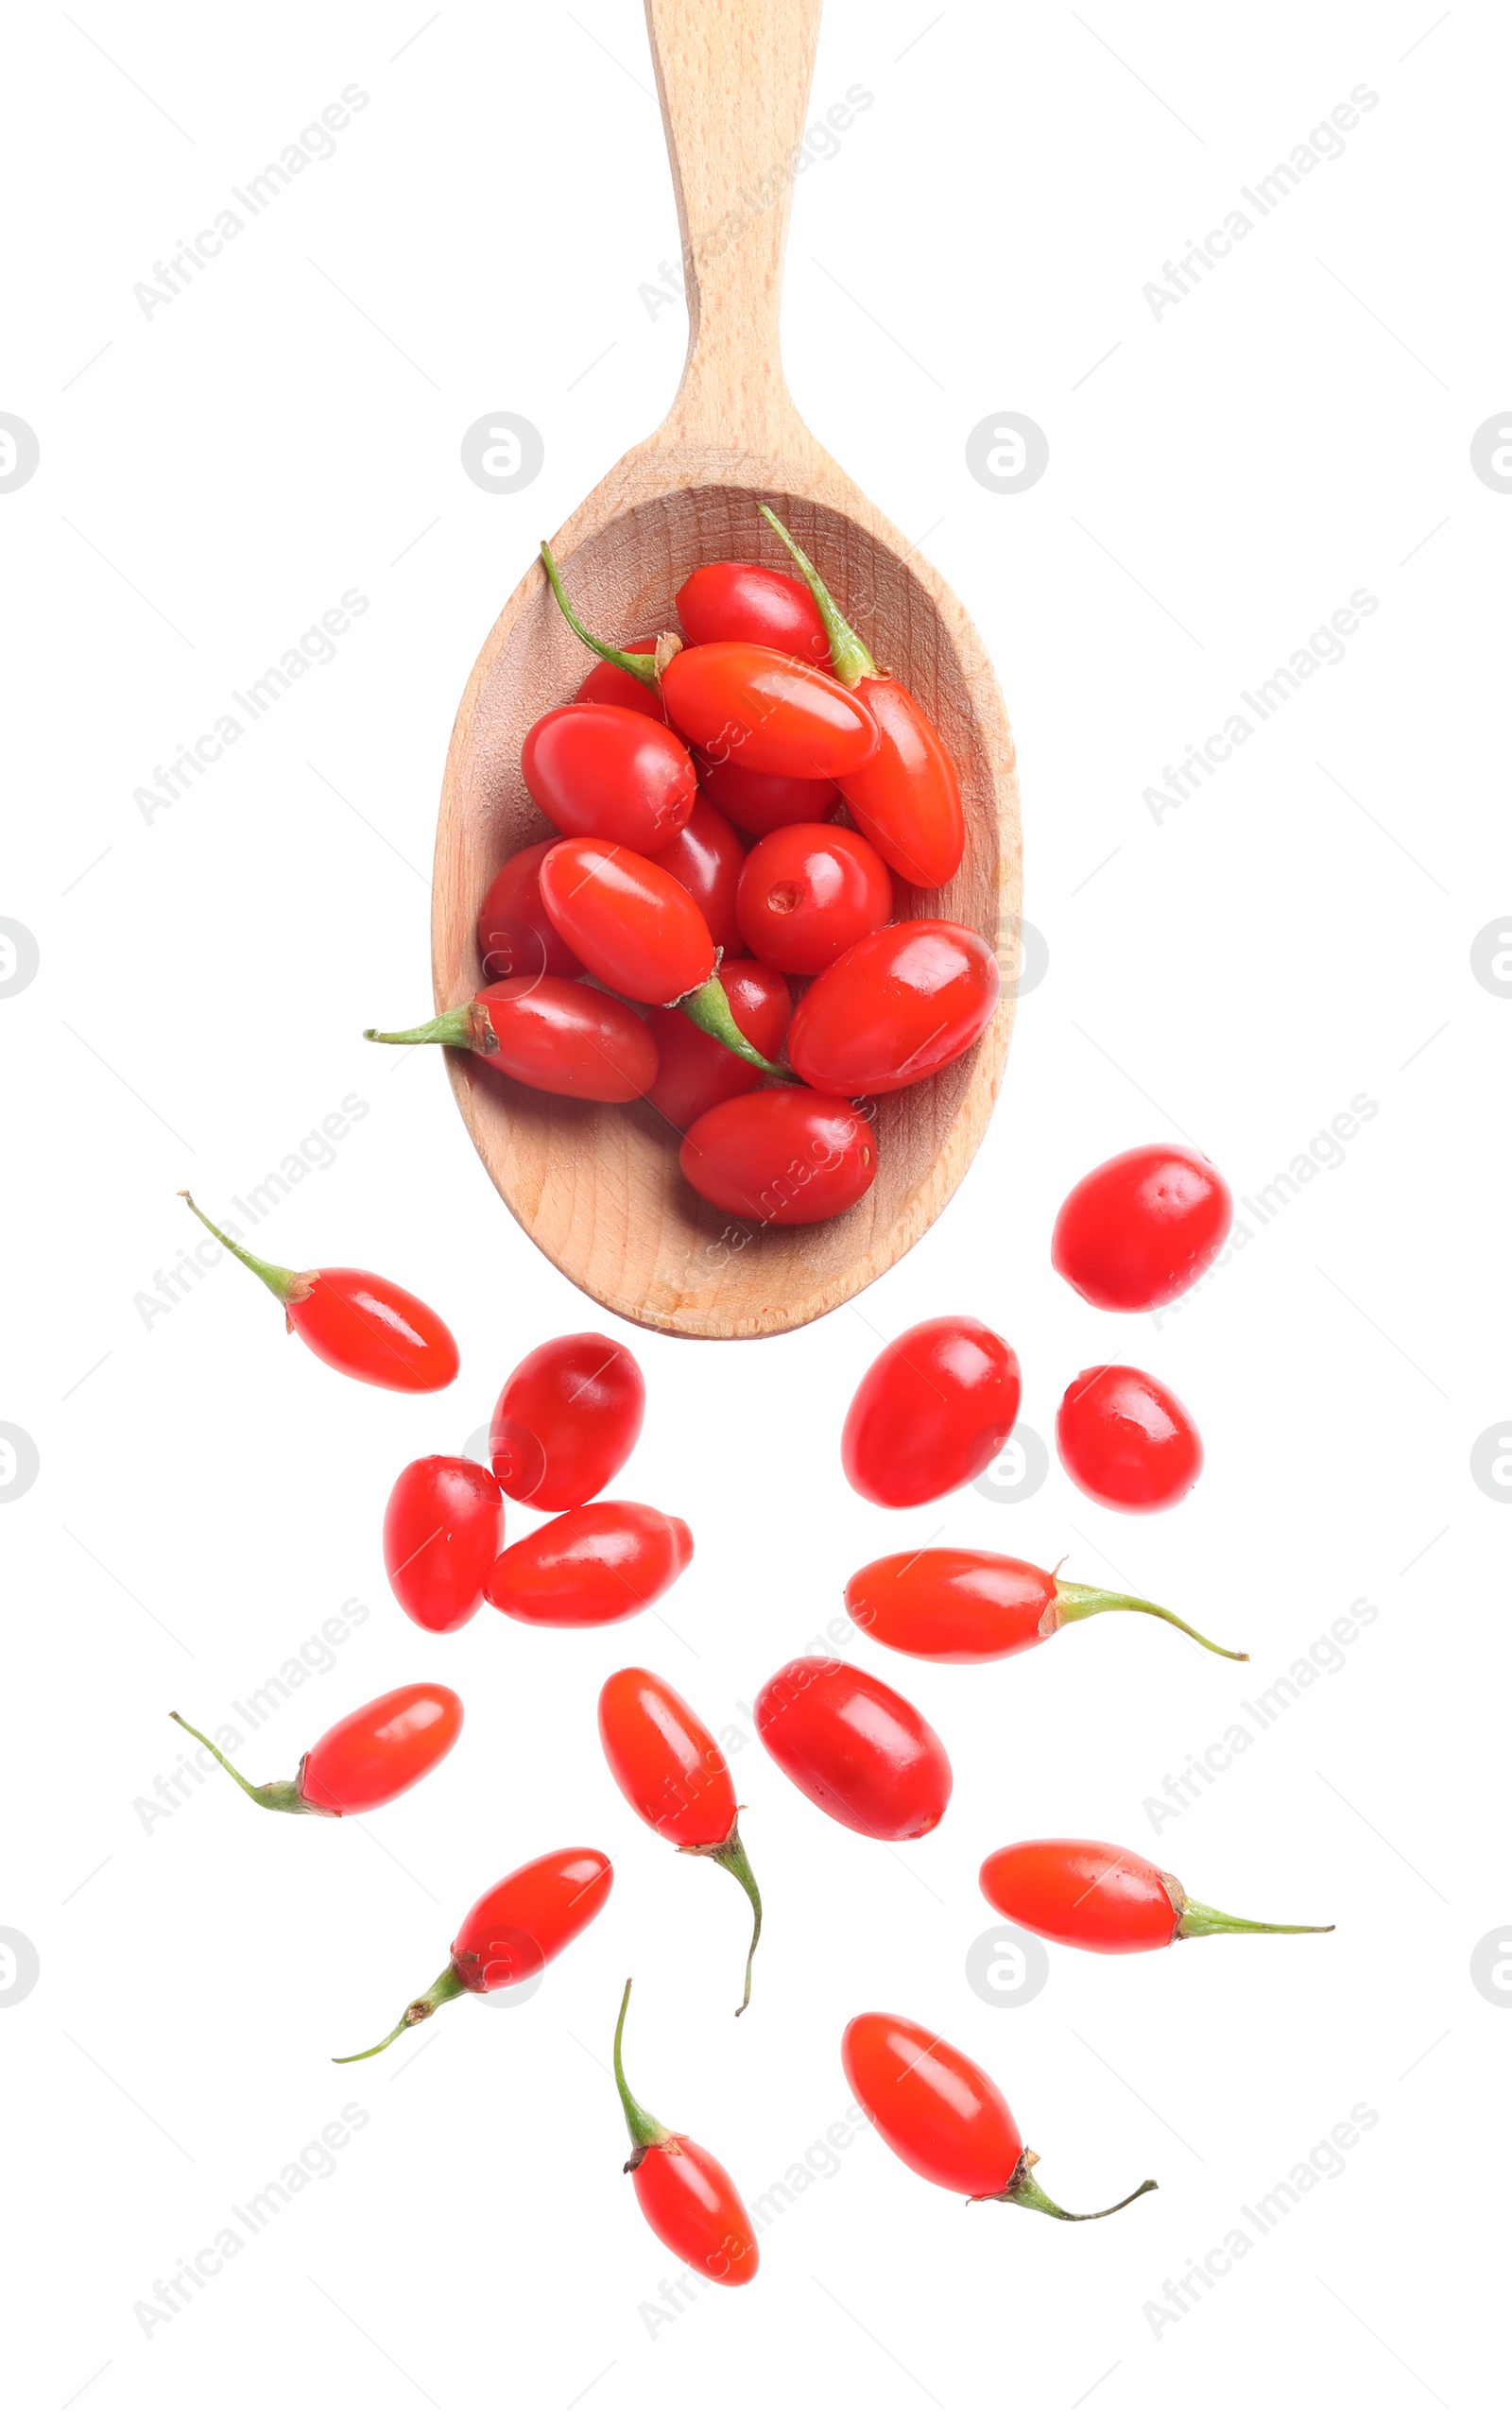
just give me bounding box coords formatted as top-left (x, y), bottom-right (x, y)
top-left (490, 1330), bottom-right (644, 1514)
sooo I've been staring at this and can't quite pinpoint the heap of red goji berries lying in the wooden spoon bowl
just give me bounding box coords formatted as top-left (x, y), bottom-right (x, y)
top-left (369, 507), bottom-right (998, 1228)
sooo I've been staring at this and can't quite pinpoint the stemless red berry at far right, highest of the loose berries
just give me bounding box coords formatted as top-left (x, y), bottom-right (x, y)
top-left (1049, 1143), bottom-right (1233, 1313)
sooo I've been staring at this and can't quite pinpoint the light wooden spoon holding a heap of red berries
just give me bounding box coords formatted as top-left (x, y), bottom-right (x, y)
top-left (431, 0), bottom-right (1020, 1337)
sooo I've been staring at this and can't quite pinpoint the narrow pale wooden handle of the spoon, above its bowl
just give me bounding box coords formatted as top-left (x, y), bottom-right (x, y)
top-left (647, 0), bottom-right (821, 455)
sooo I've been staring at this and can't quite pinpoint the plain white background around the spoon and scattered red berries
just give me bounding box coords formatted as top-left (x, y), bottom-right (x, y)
top-left (0, 0), bottom-right (1512, 2422)
